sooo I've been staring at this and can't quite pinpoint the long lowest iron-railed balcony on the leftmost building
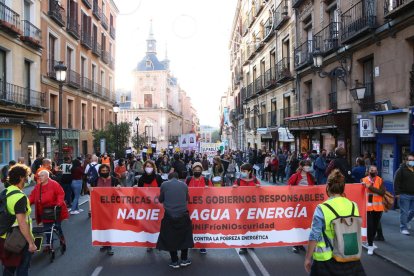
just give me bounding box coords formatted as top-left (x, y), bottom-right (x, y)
top-left (0, 80), bottom-right (46, 111)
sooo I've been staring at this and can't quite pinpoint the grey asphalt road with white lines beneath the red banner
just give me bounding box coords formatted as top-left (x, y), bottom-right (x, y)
top-left (27, 203), bottom-right (411, 276)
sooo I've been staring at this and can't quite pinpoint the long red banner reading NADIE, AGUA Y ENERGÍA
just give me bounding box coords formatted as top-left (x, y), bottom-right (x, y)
top-left (91, 184), bottom-right (366, 248)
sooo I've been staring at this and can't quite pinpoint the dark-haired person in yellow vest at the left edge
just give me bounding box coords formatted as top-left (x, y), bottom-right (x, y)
top-left (0, 165), bottom-right (37, 275)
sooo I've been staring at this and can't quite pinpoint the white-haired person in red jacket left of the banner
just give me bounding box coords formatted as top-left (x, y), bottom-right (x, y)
top-left (29, 170), bottom-right (69, 247)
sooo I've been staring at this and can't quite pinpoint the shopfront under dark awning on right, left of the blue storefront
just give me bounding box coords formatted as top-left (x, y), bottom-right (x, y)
top-left (279, 109), bottom-right (351, 159)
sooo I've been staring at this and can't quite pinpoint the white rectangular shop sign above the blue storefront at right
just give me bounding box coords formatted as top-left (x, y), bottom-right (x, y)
top-left (375, 112), bottom-right (409, 134)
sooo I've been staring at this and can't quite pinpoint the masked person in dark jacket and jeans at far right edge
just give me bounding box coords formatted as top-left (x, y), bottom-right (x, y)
top-left (394, 152), bottom-right (414, 235)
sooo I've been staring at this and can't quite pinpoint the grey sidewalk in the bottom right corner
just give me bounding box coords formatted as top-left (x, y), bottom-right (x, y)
top-left (368, 210), bottom-right (414, 274)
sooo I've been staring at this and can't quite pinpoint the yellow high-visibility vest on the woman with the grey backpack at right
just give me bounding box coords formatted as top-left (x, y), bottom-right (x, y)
top-left (313, 196), bottom-right (359, 261)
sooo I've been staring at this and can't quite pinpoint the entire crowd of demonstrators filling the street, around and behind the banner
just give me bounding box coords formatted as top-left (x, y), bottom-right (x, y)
top-left (0, 147), bottom-right (414, 275)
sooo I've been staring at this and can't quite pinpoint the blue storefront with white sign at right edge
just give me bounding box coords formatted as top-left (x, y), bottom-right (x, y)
top-left (370, 108), bottom-right (414, 191)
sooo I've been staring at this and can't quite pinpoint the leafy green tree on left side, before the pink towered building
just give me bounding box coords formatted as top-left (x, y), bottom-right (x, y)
top-left (92, 122), bottom-right (131, 158)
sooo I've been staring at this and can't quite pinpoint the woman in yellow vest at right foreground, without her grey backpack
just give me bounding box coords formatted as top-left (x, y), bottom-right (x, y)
top-left (305, 169), bottom-right (365, 276)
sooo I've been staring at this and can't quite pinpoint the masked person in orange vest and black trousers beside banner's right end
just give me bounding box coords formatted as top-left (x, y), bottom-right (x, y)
top-left (362, 165), bottom-right (386, 255)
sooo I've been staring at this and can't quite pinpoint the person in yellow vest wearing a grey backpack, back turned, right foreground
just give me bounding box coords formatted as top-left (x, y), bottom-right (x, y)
top-left (304, 169), bottom-right (366, 276)
